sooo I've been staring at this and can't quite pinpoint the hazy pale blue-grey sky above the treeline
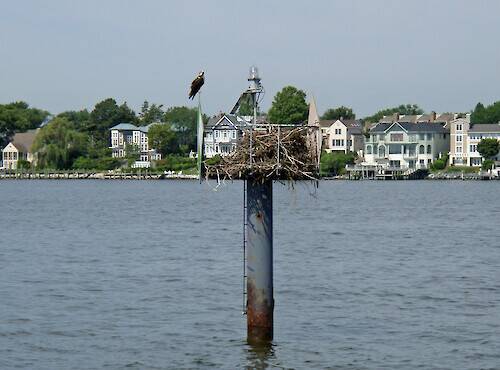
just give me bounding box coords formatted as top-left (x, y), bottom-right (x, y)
top-left (0, 0), bottom-right (500, 117)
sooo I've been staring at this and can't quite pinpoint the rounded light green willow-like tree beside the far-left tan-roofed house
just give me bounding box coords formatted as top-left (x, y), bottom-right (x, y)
top-left (33, 118), bottom-right (88, 170)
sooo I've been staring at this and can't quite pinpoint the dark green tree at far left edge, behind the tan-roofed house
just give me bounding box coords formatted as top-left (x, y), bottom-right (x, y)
top-left (0, 101), bottom-right (49, 148)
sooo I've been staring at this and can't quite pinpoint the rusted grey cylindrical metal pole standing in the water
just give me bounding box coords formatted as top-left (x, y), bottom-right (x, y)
top-left (246, 179), bottom-right (274, 343)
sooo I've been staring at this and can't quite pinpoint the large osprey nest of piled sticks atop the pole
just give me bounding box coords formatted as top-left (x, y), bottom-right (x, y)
top-left (204, 125), bottom-right (319, 181)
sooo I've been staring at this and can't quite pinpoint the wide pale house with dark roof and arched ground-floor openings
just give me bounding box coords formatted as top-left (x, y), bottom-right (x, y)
top-left (364, 121), bottom-right (450, 170)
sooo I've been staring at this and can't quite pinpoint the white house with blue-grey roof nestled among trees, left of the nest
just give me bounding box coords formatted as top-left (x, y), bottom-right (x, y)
top-left (110, 123), bottom-right (161, 168)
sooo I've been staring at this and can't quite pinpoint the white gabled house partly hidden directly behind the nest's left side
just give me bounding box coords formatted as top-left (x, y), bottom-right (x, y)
top-left (204, 113), bottom-right (251, 158)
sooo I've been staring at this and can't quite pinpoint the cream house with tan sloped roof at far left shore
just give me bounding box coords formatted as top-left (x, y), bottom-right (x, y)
top-left (2, 129), bottom-right (38, 170)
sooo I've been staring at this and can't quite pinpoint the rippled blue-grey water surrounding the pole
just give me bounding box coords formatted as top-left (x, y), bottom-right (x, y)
top-left (0, 181), bottom-right (500, 369)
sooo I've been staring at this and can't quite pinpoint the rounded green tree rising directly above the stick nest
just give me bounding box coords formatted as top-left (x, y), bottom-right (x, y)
top-left (268, 86), bottom-right (309, 124)
